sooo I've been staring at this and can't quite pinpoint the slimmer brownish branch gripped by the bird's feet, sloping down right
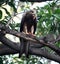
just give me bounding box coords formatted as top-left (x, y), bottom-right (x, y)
top-left (4, 29), bottom-right (60, 55)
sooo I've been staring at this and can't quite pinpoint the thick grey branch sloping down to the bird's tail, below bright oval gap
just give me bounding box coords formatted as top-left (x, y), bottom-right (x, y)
top-left (0, 36), bottom-right (20, 51)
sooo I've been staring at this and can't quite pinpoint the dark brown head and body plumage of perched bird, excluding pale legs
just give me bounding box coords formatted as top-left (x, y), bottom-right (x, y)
top-left (20, 10), bottom-right (37, 34)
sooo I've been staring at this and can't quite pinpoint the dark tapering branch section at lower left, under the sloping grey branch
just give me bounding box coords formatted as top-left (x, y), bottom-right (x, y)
top-left (0, 44), bottom-right (18, 56)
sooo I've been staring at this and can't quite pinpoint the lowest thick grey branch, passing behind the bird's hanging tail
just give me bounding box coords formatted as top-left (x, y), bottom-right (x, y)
top-left (0, 43), bottom-right (60, 63)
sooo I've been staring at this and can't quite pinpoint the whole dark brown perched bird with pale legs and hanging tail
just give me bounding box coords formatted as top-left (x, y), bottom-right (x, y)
top-left (19, 10), bottom-right (37, 57)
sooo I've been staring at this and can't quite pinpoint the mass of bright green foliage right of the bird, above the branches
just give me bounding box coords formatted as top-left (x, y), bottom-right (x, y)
top-left (37, 2), bottom-right (60, 35)
